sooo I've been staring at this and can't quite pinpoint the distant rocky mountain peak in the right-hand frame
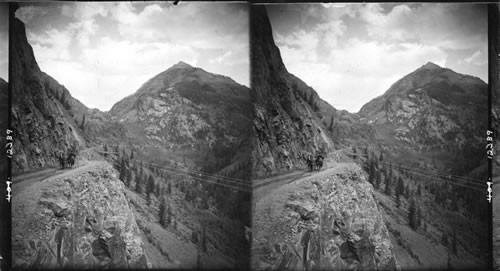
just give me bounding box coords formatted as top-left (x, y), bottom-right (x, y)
top-left (359, 62), bottom-right (488, 153)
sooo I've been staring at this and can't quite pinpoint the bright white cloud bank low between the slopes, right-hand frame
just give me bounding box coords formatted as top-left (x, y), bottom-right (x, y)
top-left (280, 39), bottom-right (447, 112)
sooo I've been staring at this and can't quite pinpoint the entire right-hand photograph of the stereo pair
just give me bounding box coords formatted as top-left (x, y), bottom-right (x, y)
top-left (250, 3), bottom-right (491, 270)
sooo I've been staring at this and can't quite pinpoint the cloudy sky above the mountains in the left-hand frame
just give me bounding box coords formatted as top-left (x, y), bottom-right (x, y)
top-left (16, 1), bottom-right (249, 111)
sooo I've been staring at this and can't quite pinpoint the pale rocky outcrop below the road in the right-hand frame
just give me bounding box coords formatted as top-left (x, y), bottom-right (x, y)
top-left (253, 165), bottom-right (397, 270)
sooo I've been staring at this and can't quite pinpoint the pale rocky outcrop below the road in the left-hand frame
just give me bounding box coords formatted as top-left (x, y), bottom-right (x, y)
top-left (12, 162), bottom-right (148, 269)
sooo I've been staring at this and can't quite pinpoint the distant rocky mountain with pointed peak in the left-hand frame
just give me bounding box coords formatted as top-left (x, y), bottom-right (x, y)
top-left (109, 61), bottom-right (252, 178)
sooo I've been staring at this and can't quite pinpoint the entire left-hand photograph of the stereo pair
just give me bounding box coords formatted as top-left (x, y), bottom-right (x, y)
top-left (10, 1), bottom-right (253, 270)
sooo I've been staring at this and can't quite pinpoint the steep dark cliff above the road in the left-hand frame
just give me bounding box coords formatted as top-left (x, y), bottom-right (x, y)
top-left (10, 15), bottom-right (93, 173)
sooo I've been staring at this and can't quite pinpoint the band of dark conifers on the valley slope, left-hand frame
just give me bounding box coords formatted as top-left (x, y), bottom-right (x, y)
top-left (109, 148), bottom-right (251, 226)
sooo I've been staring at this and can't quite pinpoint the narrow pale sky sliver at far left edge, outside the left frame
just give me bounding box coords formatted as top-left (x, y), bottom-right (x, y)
top-left (0, 3), bottom-right (9, 81)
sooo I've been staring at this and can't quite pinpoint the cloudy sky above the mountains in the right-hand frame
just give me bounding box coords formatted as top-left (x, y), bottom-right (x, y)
top-left (267, 3), bottom-right (488, 112)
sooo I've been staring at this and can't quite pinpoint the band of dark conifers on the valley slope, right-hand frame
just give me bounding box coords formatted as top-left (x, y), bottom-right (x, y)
top-left (362, 149), bottom-right (487, 255)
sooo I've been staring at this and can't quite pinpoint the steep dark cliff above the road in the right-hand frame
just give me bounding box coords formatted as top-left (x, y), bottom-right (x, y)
top-left (250, 6), bottom-right (335, 177)
